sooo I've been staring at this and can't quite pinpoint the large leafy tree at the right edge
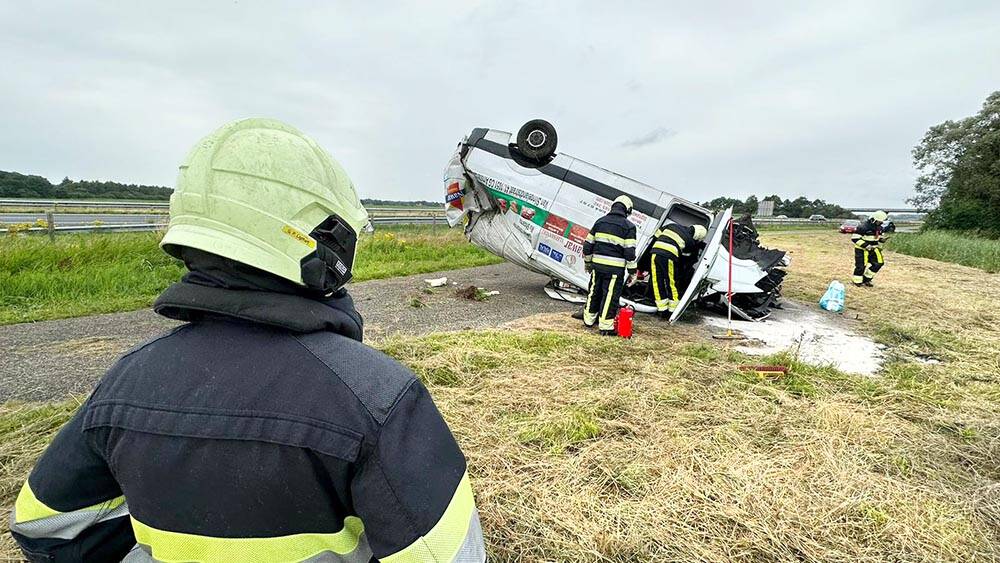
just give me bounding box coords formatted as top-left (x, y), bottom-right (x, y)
top-left (908, 91), bottom-right (1000, 238)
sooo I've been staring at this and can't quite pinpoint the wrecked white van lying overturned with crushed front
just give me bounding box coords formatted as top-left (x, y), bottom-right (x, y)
top-left (444, 120), bottom-right (787, 320)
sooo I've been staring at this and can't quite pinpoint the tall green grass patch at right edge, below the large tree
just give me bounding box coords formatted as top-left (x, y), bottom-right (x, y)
top-left (887, 231), bottom-right (1000, 273)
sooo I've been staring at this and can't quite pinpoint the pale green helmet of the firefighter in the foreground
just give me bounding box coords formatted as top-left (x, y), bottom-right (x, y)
top-left (160, 118), bottom-right (368, 292)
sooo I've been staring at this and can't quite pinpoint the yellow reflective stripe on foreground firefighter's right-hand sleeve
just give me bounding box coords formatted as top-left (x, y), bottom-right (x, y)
top-left (379, 472), bottom-right (476, 563)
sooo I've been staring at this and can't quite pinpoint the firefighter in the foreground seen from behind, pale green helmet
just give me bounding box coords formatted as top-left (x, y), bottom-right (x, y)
top-left (10, 119), bottom-right (485, 562)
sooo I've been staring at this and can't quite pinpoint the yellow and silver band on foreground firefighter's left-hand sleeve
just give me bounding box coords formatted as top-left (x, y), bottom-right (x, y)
top-left (11, 481), bottom-right (128, 540)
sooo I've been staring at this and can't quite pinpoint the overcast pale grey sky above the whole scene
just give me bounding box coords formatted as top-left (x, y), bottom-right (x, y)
top-left (0, 0), bottom-right (1000, 206)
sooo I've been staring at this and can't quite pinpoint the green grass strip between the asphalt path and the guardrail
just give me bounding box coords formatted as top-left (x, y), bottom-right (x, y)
top-left (0, 226), bottom-right (499, 324)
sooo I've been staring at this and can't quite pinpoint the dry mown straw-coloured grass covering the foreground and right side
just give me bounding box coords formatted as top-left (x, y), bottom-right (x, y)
top-left (0, 233), bottom-right (1000, 563)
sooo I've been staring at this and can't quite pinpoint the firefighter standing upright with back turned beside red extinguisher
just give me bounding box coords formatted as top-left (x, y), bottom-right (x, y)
top-left (583, 195), bottom-right (636, 335)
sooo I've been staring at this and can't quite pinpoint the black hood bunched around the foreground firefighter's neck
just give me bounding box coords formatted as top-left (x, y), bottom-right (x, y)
top-left (153, 248), bottom-right (364, 342)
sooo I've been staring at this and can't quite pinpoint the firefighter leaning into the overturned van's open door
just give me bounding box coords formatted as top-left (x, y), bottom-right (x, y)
top-left (650, 223), bottom-right (708, 319)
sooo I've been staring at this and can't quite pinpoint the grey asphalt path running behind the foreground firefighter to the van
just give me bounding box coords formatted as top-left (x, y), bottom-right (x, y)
top-left (0, 263), bottom-right (575, 402)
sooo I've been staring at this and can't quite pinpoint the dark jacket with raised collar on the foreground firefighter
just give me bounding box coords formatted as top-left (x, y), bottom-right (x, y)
top-left (11, 250), bottom-right (485, 562)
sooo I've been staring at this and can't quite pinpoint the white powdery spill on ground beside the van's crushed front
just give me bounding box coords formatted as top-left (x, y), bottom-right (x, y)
top-left (702, 301), bottom-right (885, 375)
